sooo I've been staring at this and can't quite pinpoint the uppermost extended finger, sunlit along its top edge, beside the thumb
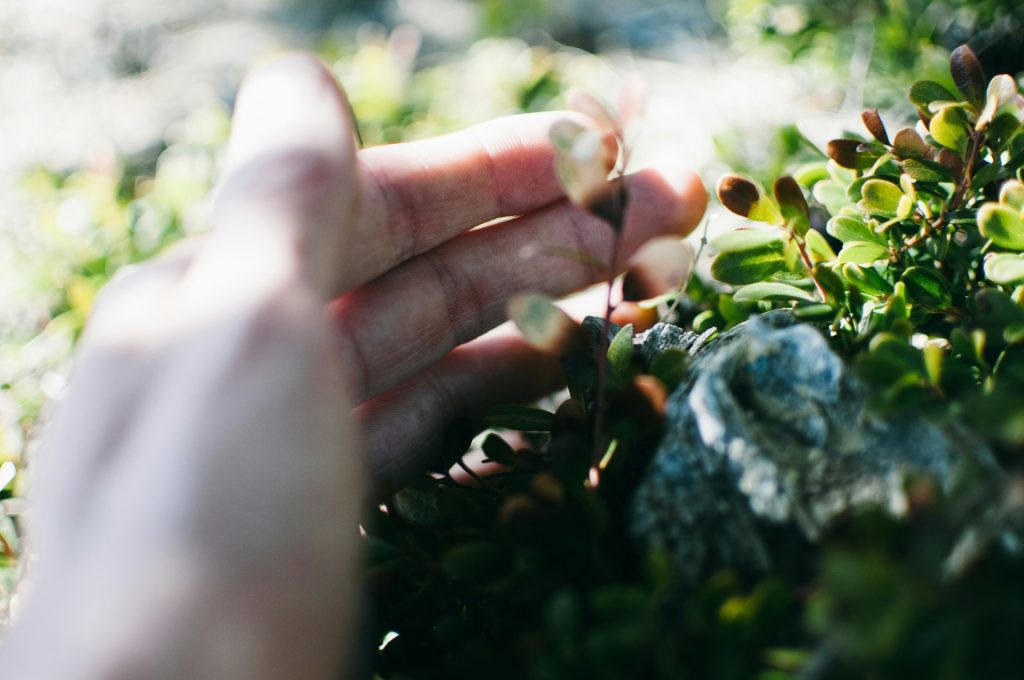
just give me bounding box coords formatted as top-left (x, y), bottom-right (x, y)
top-left (333, 112), bottom-right (583, 291)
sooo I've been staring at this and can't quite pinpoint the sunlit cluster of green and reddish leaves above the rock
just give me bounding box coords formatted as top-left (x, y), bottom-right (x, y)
top-left (712, 46), bottom-right (1024, 421)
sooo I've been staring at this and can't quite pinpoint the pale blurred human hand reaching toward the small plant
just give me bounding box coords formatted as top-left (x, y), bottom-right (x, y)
top-left (0, 55), bottom-right (706, 680)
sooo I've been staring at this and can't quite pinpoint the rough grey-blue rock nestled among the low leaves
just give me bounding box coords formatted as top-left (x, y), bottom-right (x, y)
top-left (631, 311), bottom-right (987, 583)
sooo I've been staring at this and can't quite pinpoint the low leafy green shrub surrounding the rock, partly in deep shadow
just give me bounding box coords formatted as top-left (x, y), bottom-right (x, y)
top-left (365, 48), bottom-right (1024, 678)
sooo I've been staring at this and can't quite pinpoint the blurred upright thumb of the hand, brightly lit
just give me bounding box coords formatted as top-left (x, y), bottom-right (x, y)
top-left (182, 54), bottom-right (358, 311)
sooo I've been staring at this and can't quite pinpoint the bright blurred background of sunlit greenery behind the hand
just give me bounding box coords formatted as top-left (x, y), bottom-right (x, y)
top-left (0, 0), bottom-right (1024, 625)
